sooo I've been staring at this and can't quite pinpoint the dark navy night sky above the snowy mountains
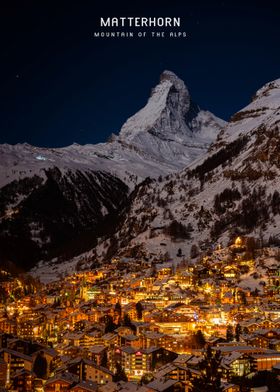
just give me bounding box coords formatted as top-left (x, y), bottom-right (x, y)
top-left (0, 0), bottom-right (280, 147)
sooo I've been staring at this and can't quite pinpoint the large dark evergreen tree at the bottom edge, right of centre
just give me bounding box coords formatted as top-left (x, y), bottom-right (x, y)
top-left (191, 346), bottom-right (223, 392)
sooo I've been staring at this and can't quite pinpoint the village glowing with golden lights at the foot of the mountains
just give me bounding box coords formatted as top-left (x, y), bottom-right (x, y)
top-left (0, 237), bottom-right (280, 392)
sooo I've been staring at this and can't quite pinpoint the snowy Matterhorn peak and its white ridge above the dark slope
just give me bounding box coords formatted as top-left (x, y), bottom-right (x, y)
top-left (0, 71), bottom-right (226, 186)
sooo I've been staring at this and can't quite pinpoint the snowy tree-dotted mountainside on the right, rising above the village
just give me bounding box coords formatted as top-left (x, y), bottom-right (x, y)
top-left (93, 79), bottom-right (280, 259)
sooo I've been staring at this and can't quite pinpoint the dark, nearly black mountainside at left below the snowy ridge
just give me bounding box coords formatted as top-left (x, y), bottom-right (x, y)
top-left (0, 168), bottom-right (128, 269)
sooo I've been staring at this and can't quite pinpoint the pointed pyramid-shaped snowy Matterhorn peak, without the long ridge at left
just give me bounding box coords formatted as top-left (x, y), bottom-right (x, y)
top-left (117, 71), bottom-right (226, 170)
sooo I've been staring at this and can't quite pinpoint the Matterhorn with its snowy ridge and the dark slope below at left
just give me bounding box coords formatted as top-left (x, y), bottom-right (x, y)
top-left (0, 71), bottom-right (226, 267)
